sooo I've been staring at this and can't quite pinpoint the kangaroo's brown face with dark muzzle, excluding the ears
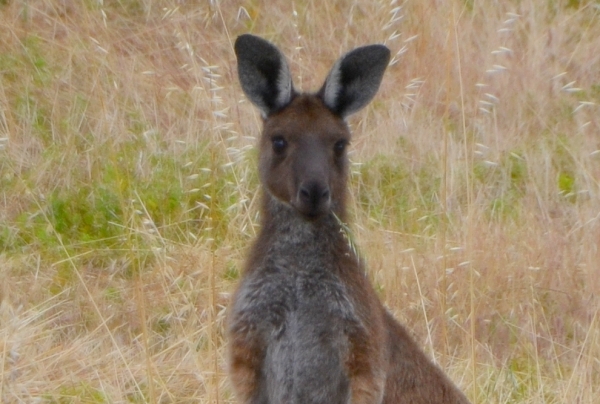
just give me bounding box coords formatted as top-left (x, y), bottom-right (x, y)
top-left (259, 95), bottom-right (350, 219)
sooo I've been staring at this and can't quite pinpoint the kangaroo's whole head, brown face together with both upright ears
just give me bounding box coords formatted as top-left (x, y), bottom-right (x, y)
top-left (235, 35), bottom-right (390, 220)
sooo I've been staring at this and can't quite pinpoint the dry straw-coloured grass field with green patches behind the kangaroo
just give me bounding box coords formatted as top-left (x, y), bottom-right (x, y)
top-left (0, 0), bottom-right (600, 404)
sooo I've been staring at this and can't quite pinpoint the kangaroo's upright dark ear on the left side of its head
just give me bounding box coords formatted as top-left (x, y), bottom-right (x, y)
top-left (235, 34), bottom-right (294, 117)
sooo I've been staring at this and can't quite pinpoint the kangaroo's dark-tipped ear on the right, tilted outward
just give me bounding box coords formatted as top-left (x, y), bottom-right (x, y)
top-left (319, 45), bottom-right (390, 118)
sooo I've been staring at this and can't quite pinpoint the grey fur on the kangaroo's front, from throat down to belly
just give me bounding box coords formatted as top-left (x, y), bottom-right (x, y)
top-left (233, 208), bottom-right (364, 403)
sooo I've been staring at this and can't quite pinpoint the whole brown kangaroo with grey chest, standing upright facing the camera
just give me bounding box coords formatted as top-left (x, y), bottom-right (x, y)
top-left (228, 35), bottom-right (469, 404)
